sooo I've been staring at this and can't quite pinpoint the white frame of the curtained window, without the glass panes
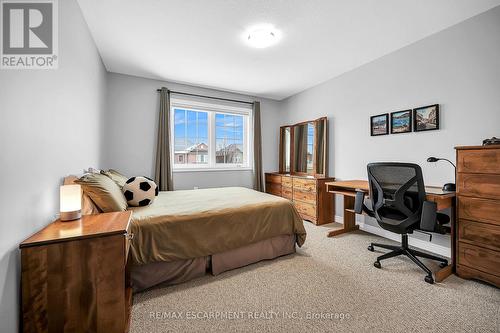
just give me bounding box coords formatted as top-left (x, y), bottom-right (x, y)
top-left (170, 98), bottom-right (253, 172)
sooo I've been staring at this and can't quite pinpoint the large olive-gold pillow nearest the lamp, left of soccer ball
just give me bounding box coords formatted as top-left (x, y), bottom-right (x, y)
top-left (75, 173), bottom-right (127, 213)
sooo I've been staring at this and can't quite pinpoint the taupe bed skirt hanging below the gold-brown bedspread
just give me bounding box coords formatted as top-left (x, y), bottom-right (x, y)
top-left (130, 235), bottom-right (295, 292)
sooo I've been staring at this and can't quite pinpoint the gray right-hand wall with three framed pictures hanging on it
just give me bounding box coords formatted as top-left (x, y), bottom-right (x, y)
top-left (282, 7), bottom-right (500, 248)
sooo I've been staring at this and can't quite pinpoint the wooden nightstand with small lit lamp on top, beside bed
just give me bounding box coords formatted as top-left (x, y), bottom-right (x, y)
top-left (19, 211), bottom-right (132, 333)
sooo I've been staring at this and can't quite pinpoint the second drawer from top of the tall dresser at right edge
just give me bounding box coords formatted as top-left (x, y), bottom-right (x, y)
top-left (457, 173), bottom-right (500, 199)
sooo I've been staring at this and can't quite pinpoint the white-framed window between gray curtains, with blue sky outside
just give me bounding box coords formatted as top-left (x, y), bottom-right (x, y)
top-left (171, 99), bottom-right (251, 170)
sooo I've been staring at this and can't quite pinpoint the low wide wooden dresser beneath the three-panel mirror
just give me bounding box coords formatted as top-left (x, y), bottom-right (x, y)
top-left (266, 173), bottom-right (335, 225)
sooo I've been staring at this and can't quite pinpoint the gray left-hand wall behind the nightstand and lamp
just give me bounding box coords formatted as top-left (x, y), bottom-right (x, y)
top-left (0, 0), bottom-right (106, 333)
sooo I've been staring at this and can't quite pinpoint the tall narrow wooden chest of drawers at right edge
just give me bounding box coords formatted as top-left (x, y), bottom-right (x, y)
top-left (456, 146), bottom-right (500, 287)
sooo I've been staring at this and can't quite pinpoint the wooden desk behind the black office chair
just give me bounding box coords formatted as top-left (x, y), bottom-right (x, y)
top-left (325, 180), bottom-right (455, 282)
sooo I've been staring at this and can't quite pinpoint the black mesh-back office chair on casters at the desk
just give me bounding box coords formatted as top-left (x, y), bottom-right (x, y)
top-left (354, 163), bottom-right (450, 284)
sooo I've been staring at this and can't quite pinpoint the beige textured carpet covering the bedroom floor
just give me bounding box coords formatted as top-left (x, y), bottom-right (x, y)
top-left (131, 223), bottom-right (500, 332)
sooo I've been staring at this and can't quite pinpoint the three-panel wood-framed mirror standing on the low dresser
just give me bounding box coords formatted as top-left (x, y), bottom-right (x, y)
top-left (279, 117), bottom-right (327, 176)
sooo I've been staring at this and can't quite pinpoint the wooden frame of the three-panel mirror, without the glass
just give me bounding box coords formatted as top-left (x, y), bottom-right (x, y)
top-left (279, 117), bottom-right (328, 178)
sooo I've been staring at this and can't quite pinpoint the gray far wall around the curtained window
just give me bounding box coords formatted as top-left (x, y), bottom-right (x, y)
top-left (103, 73), bottom-right (282, 189)
